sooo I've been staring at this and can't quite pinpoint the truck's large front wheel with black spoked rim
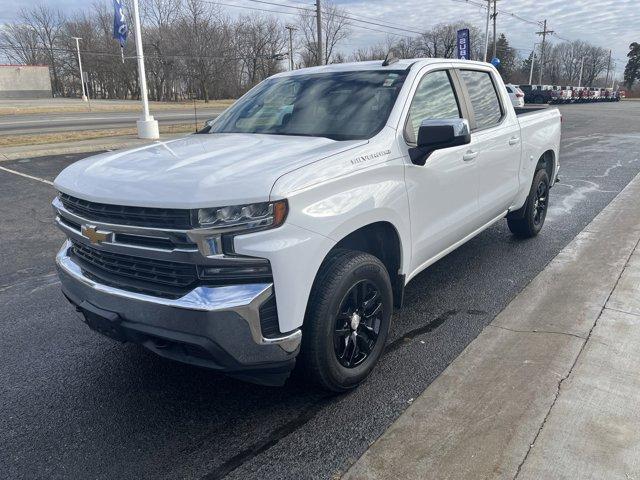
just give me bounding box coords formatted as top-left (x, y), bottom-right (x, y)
top-left (300, 250), bottom-right (393, 392)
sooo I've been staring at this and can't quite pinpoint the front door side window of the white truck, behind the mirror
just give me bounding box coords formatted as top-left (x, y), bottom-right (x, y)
top-left (404, 70), bottom-right (461, 143)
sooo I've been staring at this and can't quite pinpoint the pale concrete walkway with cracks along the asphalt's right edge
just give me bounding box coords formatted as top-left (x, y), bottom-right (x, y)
top-left (343, 174), bottom-right (640, 480)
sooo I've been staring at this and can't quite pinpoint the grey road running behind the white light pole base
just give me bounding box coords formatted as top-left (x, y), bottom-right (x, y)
top-left (0, 108), bottom-right (224, 135)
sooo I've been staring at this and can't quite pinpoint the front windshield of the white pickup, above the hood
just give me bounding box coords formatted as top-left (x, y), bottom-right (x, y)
top-left (209, 70), bottom-right (406, 140)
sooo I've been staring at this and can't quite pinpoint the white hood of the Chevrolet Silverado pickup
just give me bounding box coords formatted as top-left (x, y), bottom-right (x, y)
top-left (54, 133), bottom-right (367, 208)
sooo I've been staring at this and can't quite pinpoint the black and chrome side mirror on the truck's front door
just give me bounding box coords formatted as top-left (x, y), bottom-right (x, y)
top-left (409, 118), bottom-right (471, 165)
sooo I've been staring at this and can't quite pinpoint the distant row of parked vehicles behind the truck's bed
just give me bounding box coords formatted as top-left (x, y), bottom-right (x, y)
top-left (507, 84), bottom-right (625, 106)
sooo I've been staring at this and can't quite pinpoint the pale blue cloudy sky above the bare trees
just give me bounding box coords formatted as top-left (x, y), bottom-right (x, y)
top-left (0, 0), bottom-right (640, 76)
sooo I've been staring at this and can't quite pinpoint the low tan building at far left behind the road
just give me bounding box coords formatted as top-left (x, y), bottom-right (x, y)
top-left (0, 65), bottom-right (51, 99)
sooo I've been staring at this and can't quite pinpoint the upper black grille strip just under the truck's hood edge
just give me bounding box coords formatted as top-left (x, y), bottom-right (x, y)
top-left (60, 193), bottom-right (192, 230)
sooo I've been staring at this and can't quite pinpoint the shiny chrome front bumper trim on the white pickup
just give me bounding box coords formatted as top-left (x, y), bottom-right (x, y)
top-left (56, 240), bottom-right (302, 352)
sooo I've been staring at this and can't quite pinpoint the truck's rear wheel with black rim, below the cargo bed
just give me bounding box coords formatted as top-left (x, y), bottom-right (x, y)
top-left (507, 170), bottom-right (550, 238)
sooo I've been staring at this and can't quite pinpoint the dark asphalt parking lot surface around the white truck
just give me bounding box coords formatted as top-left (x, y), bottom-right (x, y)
top-left (0, 101), bottom-right (640, 479)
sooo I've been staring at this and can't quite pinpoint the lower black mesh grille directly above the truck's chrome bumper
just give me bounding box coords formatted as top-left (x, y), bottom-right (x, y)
top-left (70, 242), bottom-right (198, 298)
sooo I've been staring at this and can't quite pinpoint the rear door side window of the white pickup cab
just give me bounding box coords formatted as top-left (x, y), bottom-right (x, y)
top-left (460, 70), bottom-right (502, 130)
